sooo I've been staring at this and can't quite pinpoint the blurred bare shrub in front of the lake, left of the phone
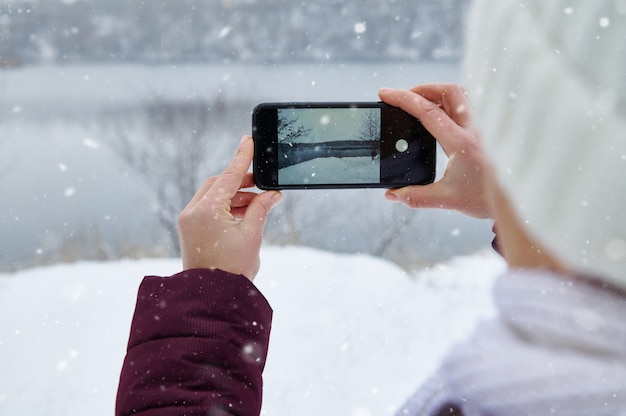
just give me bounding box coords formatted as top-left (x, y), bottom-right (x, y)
top-left (106, 100), bottom-right (238, 251)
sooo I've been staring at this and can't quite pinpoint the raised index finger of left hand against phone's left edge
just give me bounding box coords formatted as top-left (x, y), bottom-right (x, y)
top-left (211, 136), bottom-right (254, 200)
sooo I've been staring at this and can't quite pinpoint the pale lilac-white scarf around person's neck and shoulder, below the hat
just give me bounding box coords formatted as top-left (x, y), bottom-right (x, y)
top-left (398, 271), bottom-right (626, 416)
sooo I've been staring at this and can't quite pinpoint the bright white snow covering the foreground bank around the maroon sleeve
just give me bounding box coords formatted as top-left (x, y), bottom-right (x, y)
top-left (0, 247), bottom-right (503, 416)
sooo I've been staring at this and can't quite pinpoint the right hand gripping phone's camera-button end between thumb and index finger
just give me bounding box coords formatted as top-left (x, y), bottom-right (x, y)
top-left (379, 84), bottom-right (491, 218)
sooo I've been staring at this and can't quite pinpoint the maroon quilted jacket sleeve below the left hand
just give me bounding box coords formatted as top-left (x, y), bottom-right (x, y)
top-left (116, 269), bottom-right (272, 416)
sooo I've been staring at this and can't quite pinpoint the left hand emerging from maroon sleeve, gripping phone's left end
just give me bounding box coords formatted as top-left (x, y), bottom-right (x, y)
top-left (178, 136), bottom-right (282, 280)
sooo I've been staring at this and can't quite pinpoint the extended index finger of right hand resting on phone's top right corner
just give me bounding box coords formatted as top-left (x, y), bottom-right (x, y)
top-left (379, 89), bottom-right (463, 155)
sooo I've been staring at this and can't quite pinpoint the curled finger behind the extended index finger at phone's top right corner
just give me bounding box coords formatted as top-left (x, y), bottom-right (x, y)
top-left (411, 83), bottom-right (472, 127)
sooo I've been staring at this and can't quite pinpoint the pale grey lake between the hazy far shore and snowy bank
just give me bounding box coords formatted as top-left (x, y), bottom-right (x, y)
top-left (0, 63), bottom-right (491, 270)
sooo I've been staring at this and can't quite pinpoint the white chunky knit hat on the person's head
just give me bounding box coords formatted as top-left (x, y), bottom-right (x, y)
top-left (466, 0), bottom-right (626, 289)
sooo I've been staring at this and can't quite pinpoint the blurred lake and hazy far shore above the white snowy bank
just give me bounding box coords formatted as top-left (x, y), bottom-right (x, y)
top-left (0, 0), bottom-right (491, 271)
